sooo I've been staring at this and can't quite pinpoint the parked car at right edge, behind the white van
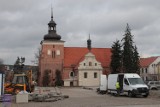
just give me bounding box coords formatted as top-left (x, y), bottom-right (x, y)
top-left (147, 81), bottom-right (160, 90)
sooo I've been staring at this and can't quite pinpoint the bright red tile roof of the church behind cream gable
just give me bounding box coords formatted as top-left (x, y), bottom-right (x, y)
top-left (64, 47), bottom-right (111, 67)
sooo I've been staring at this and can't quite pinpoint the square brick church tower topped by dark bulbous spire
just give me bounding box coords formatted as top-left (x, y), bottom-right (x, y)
top-left (38, 8), bottom-right (64, 86)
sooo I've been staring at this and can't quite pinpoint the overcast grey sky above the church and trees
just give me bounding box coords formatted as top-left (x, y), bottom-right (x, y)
top-left (0, 0), bottom-right (160, 64)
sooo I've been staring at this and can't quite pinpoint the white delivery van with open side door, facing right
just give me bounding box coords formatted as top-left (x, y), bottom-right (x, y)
top-left (108, 73), bottom-right (149, 97)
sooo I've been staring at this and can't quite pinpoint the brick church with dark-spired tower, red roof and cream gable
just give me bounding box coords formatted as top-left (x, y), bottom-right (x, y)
top-left (38, 9), bottom-right (111, 86)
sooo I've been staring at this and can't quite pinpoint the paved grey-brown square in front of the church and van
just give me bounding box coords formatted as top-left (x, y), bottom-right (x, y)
top-left (0, 87), bottom-right (160, 107)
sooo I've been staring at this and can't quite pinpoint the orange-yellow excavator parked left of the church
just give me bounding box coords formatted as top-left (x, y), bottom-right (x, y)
top-left (4, 70), bottom-right (34, 94)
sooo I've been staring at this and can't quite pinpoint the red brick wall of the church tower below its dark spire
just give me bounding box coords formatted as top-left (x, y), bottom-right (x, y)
top-left (39, 41), bottom-right (64, 86)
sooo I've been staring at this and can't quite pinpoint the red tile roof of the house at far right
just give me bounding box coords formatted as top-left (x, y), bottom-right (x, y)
top-left (140, 57), bottom-right (158, 67)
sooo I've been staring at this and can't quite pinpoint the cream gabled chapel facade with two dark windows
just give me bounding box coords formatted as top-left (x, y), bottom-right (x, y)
top-left (78, 52), bottom-right (102, 86)
